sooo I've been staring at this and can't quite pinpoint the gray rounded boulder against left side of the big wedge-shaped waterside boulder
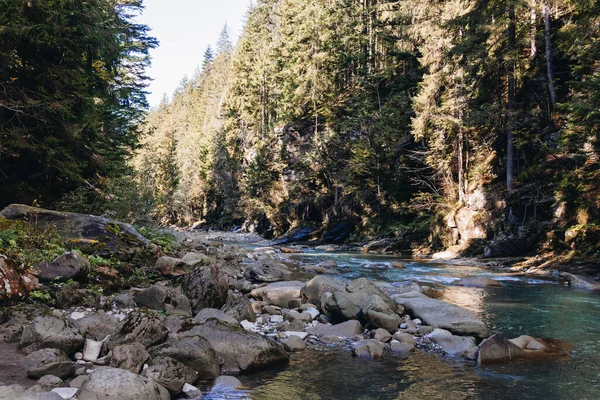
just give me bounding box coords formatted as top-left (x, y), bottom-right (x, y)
top-left (149, 336), bottom-right (220, 383)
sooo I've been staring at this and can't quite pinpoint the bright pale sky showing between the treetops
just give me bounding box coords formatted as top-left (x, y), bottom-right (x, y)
top-left (137, 0), bottom-right (250, 107)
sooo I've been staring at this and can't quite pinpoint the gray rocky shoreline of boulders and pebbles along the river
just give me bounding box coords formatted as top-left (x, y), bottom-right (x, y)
top-left (0, 206), bottom-right (584, 400)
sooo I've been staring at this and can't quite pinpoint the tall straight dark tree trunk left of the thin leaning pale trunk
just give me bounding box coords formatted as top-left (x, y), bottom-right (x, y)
top-left (506, 2), bottom-right (516, 192)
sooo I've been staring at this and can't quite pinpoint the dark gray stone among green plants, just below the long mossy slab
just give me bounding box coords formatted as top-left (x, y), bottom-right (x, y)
top-left (38, 251), bottom-right (91, 282)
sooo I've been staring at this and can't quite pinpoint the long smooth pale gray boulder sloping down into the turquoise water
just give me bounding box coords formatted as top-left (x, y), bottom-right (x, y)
top-left (393, 292), bottom-right (490, 339)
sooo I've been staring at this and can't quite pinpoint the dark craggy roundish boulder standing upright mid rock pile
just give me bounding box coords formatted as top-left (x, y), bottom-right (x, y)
top-left (181, 265), bottom-right (229, 312)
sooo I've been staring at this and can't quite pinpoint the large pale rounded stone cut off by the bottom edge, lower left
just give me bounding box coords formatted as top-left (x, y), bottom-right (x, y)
top-left (77, 367), bottom-right (171, 400)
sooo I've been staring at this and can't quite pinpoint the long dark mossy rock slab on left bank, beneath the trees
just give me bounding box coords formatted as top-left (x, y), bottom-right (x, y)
top-left (0, 204), bottom-right (151, 256)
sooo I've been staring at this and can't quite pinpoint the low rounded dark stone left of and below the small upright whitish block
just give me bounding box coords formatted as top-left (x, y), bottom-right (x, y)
top-left (21, 348), bottom-right (73, 379)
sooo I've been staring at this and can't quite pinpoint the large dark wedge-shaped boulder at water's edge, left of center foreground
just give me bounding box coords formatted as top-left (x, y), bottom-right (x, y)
top-left (179, 318), bottom-right (289, 373)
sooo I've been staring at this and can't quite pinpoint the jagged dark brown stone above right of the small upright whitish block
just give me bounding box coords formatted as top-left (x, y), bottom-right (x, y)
top-left (111, 310), bottom-right (169, 347)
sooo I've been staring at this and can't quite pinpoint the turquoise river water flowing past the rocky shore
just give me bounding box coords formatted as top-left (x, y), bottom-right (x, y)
top-left (212, 253), bottom-right (600, 400)
